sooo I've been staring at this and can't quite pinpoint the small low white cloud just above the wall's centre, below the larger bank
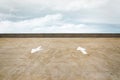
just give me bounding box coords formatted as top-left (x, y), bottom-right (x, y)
top-left (32, 23), bottom-right (91, 33)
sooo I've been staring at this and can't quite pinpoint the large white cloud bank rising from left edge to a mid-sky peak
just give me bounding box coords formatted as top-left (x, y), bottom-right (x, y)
top-left (0, 14), bottom-right (100, 33)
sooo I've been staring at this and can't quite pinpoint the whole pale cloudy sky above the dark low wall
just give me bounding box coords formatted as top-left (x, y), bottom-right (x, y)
top-left (0, 0), bottom-right (120, 33)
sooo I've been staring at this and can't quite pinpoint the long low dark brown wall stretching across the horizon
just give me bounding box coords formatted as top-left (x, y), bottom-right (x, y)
top-left (0, 33), bottom-right (120, 38)
